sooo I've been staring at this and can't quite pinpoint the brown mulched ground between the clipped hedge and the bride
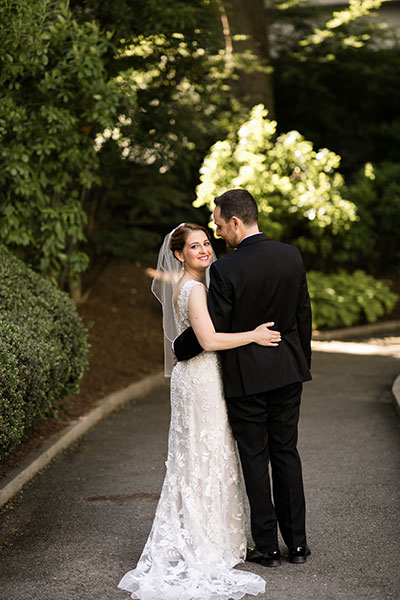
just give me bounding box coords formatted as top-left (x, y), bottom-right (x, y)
top-left (0, 261), bottom-right (163, 477)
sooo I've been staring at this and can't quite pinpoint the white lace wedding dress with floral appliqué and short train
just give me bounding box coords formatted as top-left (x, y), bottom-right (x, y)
top-left (118, 280), bottom-right (265, 600)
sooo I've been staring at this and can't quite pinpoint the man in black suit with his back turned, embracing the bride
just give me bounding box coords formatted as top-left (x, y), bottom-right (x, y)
top-left (174, 189), bottom-right (311, 567)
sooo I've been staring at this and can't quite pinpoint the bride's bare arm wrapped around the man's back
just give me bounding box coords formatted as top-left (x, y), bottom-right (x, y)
top-left (189, 285), bottom-right (281, 351)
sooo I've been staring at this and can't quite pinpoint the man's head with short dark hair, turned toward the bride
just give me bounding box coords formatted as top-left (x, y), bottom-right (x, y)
top-left (213, 189), bottom-right (258, 248)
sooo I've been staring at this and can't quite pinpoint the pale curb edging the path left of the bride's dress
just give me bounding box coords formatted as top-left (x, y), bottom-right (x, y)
top-left (0, 372), bottom-right (168, 507)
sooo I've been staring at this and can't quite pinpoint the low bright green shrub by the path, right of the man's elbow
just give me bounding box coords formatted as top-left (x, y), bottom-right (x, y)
top-left (307, 270), bottom-right (398, 329)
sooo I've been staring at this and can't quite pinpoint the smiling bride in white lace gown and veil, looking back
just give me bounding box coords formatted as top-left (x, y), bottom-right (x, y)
top-left (118, 223), bottom-right (280, 600)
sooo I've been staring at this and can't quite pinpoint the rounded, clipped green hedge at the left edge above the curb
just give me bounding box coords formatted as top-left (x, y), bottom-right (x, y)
top-left (0, 246), bottom-right (89, 456)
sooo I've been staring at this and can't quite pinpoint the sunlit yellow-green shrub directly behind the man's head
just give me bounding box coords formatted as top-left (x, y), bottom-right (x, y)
top-left (193, 105), bottom-right (357, 264)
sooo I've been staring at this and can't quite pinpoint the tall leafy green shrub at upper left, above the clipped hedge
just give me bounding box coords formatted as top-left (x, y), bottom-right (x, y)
top-left (0, 0), bottom-right (126, 283)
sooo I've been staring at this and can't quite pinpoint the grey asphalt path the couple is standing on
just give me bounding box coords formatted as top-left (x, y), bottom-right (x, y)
top-left (0, 346), bottom-right (400, 600)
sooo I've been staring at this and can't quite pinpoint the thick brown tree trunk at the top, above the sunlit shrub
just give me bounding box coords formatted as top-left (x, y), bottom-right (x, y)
top-left (217, 0), bottom-right (274, 117)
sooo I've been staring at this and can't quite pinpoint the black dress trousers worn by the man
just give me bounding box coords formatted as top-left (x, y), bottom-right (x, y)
top-left (227, 383), bottom-right (306, 552)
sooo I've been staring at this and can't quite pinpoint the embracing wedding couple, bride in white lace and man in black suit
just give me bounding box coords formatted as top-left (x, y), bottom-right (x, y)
top-left (118, 189), bottom-right (311, 600)
